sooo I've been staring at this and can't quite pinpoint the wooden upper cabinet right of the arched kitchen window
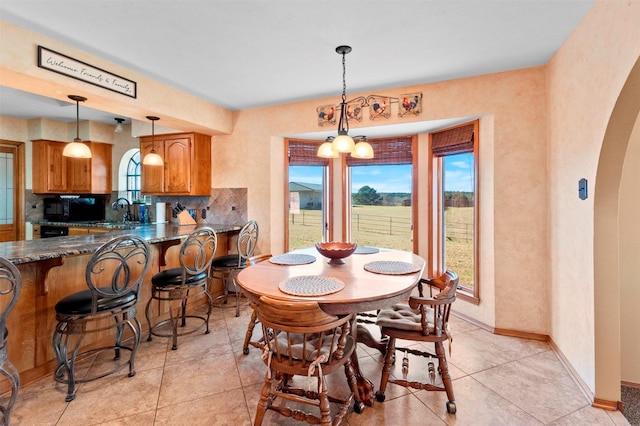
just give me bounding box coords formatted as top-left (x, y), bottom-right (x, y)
top-left (140, 132), bottom-right (211, 195)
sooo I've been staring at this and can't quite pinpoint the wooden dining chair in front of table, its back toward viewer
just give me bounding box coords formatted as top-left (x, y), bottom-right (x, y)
top-left (252, 296), bottom-right (360, 425)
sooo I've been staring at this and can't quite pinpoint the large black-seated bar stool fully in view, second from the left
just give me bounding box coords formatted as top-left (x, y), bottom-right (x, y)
top-left (52, 235), bottom-right (151, 402)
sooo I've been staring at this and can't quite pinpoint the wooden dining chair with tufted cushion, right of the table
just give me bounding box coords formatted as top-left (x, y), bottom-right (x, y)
top-left (376, 270), bottom-right (458, 414)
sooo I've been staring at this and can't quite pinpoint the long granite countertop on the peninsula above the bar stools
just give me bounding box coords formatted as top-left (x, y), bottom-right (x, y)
top-left (0, 223), bottom-right (242, 265)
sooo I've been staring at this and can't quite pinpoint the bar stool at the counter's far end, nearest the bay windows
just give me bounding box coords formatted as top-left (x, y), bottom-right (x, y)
top-left (211, 220), bottom-right (258, 317)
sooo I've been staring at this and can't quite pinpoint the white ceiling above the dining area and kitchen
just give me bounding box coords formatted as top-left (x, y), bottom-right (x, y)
top-left (0, 0), bottom-right (595, 136)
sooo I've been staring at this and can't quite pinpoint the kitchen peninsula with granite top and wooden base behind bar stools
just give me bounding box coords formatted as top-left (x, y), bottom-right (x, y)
top-left (0, 224), bottom-right (241, 390)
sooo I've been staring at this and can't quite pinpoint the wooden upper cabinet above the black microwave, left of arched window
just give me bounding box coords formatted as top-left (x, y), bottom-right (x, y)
top-left (32, 139), bottom-right (112, 194)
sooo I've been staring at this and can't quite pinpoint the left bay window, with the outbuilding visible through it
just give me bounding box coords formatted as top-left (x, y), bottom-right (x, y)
top-left (286, 140), bottom-right (329, 250)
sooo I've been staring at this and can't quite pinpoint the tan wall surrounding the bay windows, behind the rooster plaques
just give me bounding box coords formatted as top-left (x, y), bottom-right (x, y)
top-left (213, 67), bottom-right (549, 334)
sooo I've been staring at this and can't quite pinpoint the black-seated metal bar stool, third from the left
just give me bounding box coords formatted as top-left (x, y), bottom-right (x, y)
top-left (145, 226), bottom-right (218, 350)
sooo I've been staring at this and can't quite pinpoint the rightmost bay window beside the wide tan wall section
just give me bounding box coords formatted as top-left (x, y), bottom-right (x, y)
top-left (430, 121), bottom-right (479, 300)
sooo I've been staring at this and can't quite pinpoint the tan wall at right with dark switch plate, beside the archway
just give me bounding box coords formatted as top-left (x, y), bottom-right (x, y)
top-left (548, 1), bottom-right (640, 400)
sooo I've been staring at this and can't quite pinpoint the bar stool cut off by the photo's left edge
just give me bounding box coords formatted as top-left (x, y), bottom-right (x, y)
top-left (0, 257), bottom-right (22, 425)
